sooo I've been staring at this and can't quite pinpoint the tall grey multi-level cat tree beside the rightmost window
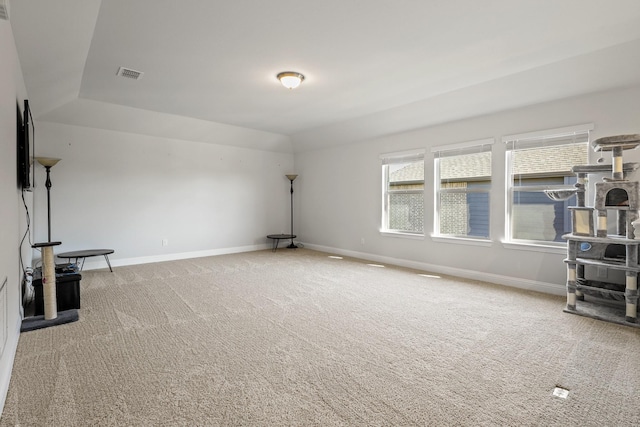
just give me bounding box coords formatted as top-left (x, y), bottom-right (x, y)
top-left (560, 135), bottom-right (640, 327)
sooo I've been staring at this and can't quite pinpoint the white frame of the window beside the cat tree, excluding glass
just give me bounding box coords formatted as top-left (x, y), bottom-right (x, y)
top-left (502, 123), bottom-right (594, 249)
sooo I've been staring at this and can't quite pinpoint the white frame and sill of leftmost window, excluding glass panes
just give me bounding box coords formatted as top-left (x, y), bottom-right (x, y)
top-left (379, 149), bottom-right (426, 239)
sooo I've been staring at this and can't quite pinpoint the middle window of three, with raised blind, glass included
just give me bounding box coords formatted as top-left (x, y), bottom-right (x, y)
top-left (432, 139), bottom-right (494, 239)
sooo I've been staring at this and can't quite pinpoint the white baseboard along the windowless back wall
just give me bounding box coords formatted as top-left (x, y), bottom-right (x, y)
top-left (83, 243), bottom-right (271, 270)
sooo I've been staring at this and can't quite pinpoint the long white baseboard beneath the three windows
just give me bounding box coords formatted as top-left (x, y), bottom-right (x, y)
top-left (304, 243), bottom-right (566, 296)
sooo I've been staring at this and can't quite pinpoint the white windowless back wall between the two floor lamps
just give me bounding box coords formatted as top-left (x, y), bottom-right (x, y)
top-left (34, 122), bottom-right (293, 268)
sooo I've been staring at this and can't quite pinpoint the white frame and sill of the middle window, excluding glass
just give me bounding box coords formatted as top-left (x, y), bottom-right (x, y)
top-left (431, 138), bottom-right (495, 242)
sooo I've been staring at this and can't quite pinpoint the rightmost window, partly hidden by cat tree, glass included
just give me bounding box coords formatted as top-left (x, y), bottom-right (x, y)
top-left (503, 124), bottom-right (593, 246)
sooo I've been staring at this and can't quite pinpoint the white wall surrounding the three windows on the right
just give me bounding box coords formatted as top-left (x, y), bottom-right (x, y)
top-left (294, 87), bottom-right (640, 294)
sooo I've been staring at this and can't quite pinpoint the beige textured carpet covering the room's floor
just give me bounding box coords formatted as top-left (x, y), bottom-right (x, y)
top-left (0, 249), bottom-right (640, 426)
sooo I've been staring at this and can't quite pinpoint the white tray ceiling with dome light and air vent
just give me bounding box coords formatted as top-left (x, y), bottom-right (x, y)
top-left (10, 0), bottom-right (640, 150)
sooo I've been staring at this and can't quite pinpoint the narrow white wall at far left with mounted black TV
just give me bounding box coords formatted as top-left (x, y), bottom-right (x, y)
top-left (0, 20), bottom-right (32, 408)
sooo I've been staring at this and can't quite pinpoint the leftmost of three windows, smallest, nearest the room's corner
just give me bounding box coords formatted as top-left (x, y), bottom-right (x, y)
top-left (380, 150), bottom-right (424, 235)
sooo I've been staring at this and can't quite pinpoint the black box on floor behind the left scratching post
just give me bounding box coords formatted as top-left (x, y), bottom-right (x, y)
top-left (33, 268), bottom-right (82, 316)
